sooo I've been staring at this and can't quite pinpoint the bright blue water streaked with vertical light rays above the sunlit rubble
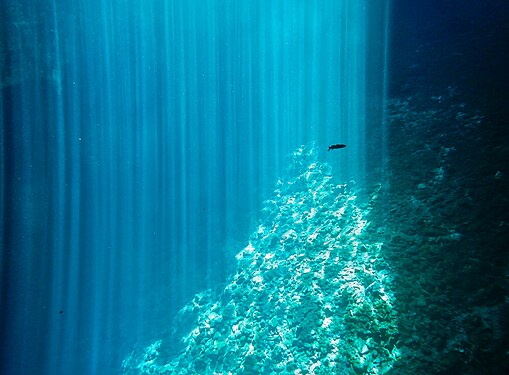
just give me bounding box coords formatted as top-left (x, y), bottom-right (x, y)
top-left (0, 0), bottom-right (385, 374)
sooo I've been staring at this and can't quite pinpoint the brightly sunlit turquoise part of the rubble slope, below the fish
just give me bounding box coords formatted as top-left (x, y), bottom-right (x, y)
top-left (123, 146), bottom-right (399, 374)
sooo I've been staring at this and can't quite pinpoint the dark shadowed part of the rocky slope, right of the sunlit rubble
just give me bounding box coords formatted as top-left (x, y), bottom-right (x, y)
top-left (372, 92), bottom-right (509, 375)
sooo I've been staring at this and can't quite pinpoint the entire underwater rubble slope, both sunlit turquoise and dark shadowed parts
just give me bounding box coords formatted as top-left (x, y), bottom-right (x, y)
top-left (124, 93), bottom-right (509, 375)
